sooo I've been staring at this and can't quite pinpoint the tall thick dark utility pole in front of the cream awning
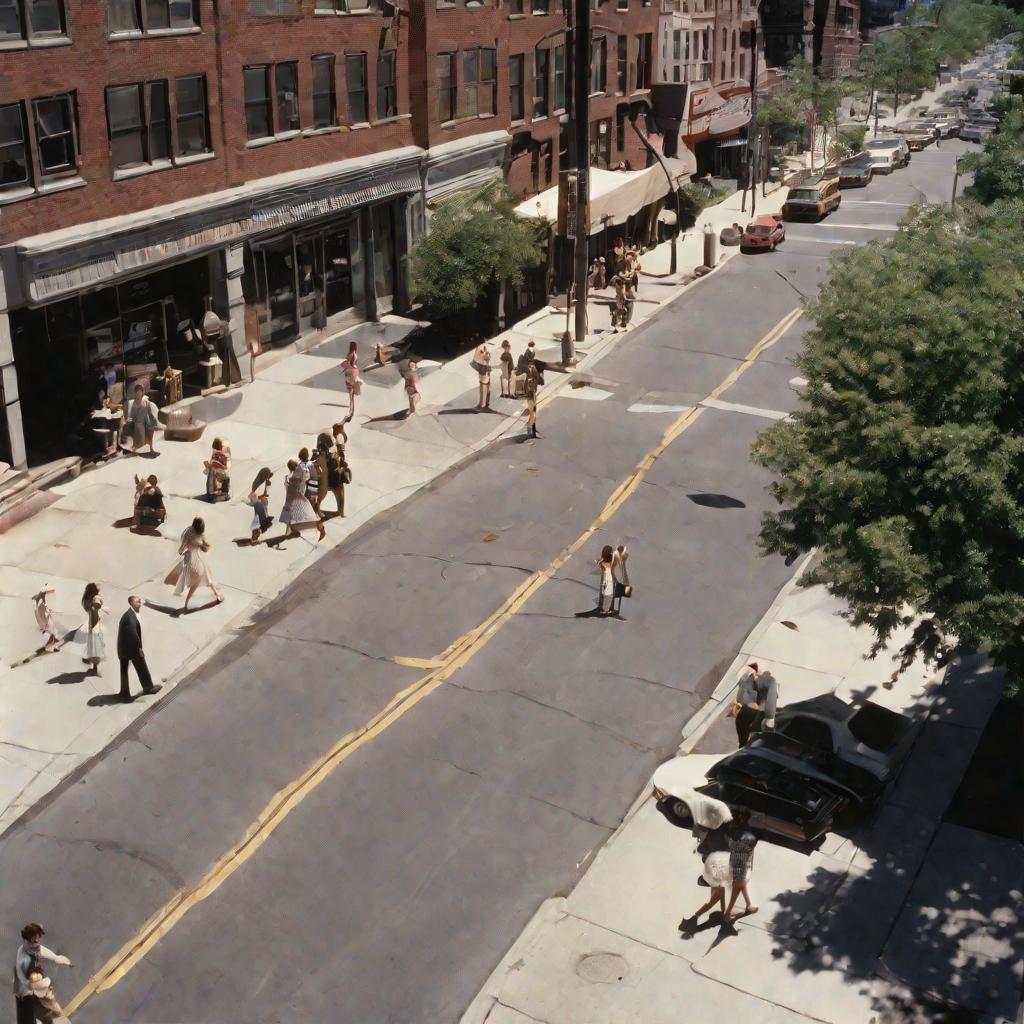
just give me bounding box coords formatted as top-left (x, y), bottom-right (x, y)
top-left (562, 0), bottom-right (592, 367)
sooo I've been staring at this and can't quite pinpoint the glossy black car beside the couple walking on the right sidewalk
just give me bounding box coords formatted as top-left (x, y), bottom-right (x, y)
top-left (697, 748), bottom-right (852, 843)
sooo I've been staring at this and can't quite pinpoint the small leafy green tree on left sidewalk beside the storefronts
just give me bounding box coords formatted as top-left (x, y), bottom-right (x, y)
top-left (413, 181), bottom-right (548, 316)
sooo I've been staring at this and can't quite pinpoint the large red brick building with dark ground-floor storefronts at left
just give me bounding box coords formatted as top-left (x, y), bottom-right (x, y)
top-left (0, 0), bottom-right (659, 466)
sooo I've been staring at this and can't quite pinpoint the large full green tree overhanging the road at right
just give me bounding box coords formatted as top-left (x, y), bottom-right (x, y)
top-left (753, 201), bottom-right (1024, 681)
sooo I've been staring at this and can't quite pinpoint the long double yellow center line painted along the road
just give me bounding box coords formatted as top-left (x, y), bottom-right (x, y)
top-left (65, 308), bottom-right (802, 1016)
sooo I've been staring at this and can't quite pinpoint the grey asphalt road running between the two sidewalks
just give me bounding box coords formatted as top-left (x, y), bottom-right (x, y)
top-left (0, 142), bottom-right (964, 1024)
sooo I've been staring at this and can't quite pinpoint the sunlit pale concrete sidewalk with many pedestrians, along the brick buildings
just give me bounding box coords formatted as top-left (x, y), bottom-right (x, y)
top-left (0, 174), bottom-right (781, 831)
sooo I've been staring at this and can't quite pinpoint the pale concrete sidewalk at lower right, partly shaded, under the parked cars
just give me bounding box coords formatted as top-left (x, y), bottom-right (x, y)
top-left (462, 569), bottom-right (1024, 1024)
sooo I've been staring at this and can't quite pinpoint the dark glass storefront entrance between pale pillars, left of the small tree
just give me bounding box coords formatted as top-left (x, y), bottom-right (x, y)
top-left (243, 218), bottom-right (365, 348)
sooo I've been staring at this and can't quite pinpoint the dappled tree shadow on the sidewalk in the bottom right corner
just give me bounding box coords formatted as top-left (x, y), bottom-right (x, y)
top-left (767, 673), bottom-right (1024, 1024)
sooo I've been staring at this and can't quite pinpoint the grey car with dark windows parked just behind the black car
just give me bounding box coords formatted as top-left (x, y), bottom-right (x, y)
top-left (759, 693), bottom-right (918, 785)
